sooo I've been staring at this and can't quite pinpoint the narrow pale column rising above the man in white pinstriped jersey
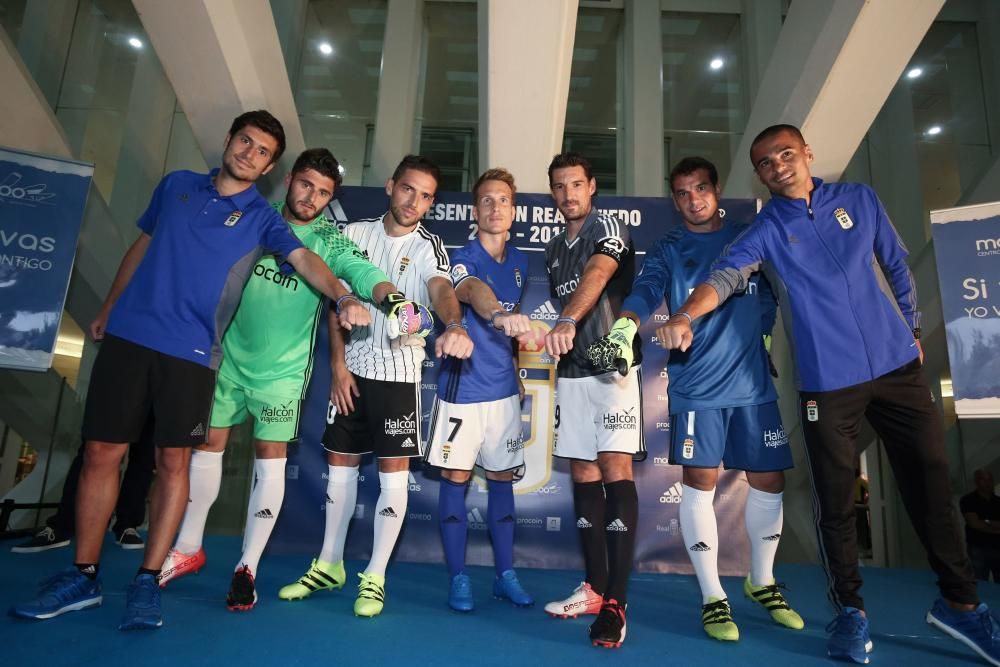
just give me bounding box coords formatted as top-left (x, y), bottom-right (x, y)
top-left (372, 0), bottom-right (424, 185)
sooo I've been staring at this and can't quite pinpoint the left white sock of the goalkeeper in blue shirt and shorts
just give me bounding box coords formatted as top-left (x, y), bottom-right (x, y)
top-left (680, 484), bottom-right (726, 604)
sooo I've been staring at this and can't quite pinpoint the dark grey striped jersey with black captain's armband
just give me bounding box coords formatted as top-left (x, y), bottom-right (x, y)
top-left (545, 209), bottom-right (642, 378)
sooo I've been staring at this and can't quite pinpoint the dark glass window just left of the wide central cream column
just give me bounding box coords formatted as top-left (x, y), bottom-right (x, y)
top-left (417, 2), bottom-right (479, 192)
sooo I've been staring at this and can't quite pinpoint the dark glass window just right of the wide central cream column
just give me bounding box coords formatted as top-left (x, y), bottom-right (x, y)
top-left (563, 7), bottom-right (624, 194)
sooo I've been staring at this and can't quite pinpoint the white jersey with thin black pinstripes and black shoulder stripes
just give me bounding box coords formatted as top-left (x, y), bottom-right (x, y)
top-left (344, 213), bottom-right (451, 382)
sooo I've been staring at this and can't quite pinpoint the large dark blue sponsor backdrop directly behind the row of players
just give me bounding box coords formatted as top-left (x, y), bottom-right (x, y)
top-left (271, 187), bottom-right (757, 574)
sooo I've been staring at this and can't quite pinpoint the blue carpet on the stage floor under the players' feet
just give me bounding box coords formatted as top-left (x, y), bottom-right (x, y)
top-left (0, 537), bottom-right (1000, 667)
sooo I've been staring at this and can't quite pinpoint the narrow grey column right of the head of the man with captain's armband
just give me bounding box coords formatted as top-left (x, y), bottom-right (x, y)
top-left (618, 0), bottom-right (665, 197)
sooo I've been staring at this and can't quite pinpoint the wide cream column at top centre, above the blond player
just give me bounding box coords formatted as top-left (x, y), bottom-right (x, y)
top-left (479, 0), bottom-right (580, 192)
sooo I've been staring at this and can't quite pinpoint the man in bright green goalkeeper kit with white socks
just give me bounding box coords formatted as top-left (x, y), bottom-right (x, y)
top-left (160, 148), bottom-right (433, 611)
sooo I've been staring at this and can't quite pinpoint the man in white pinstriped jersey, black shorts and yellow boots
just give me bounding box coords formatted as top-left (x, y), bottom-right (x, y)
top-left (278, 155), bottom-right (473, 617)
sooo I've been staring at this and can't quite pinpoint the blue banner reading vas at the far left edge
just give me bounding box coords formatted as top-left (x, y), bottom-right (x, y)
top-left (0, 149), bottom-right (94, 371)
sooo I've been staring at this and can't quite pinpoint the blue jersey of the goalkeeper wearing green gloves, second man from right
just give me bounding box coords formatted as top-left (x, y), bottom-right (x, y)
top-left (622, 223), bottom-right (777, 414)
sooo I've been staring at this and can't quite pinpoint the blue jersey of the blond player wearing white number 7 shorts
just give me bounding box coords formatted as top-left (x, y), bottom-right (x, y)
top-left (438, 238), bottom-right (528, 403)
